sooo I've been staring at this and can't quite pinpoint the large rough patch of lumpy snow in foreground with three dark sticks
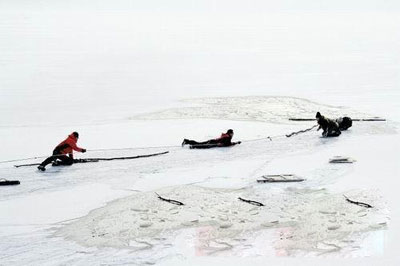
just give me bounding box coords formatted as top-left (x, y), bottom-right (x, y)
top-left (57, 185), bottom-right (388, 255)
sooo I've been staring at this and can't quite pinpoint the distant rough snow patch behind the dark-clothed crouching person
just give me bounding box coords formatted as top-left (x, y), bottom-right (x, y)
top-left (130, 96), bottom-right (371, 123)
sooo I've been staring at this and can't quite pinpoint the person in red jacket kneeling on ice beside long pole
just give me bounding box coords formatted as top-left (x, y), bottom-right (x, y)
top-left (38, 132), bottom-right (86, 171)
